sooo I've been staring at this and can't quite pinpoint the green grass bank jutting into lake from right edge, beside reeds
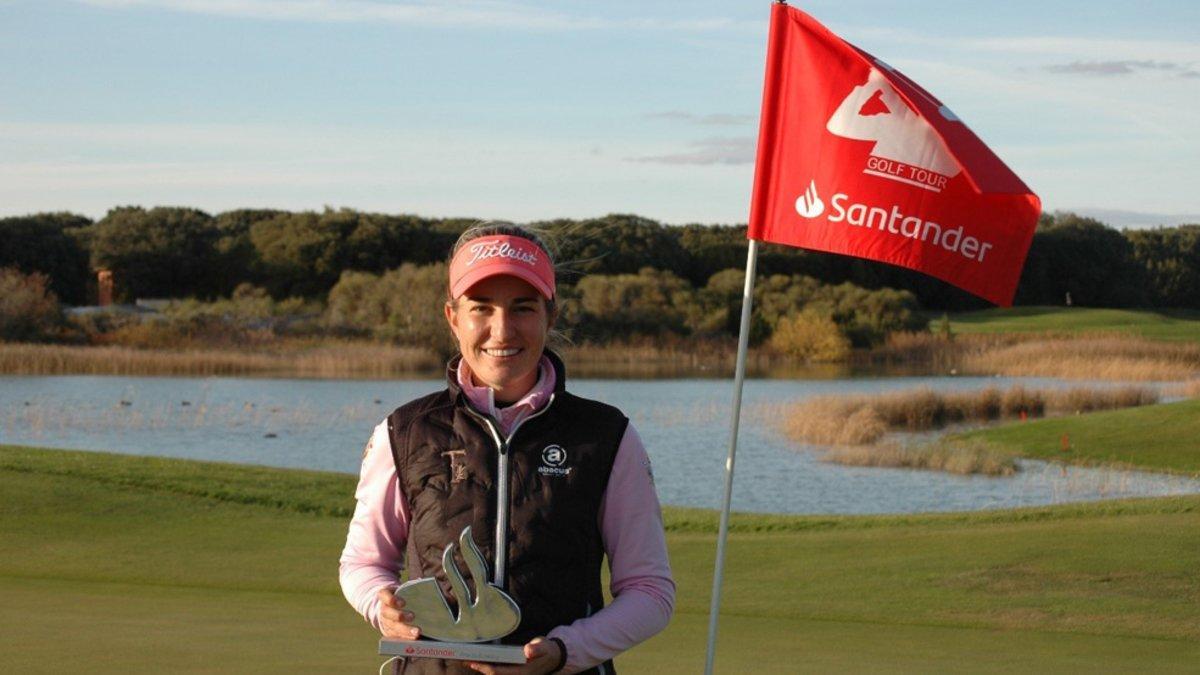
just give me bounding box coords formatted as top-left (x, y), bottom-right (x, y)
top-left (959, 399), bottom-right (1200, 474)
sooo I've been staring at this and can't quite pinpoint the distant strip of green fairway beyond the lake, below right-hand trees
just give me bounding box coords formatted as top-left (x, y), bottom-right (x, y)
top-left (931, 306), bottom-right (1200, 341)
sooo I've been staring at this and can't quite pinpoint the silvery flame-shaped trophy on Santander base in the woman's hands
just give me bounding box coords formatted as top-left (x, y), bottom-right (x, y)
top-left (379, 526), bottom-right (526, 663)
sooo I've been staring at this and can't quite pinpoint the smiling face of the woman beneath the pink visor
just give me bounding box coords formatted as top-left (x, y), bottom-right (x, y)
top-left (445, 275), bottom-right (554, 402)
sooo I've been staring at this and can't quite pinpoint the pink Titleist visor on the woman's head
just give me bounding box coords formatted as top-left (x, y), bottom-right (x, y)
top-left (450, 234), bottom-right (554, 299)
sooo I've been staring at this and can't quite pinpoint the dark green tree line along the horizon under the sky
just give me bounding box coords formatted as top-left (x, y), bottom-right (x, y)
top-left (0, 207), bottom-right (1200, 309)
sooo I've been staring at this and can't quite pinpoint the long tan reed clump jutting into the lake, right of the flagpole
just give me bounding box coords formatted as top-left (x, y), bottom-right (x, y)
top-left (780, 386), bottom-right (1159, 446)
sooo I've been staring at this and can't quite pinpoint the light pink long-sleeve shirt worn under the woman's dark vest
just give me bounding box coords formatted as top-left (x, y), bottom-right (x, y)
top-left (338, 357), bottom-right (674, 673)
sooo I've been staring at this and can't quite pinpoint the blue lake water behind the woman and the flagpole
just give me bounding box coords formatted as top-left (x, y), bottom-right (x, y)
top-left (0, 376), bottom-right (1200, 514)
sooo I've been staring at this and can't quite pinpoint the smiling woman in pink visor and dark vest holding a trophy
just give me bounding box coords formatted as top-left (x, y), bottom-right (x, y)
top-left (341, 223), bottom-right (674, 674)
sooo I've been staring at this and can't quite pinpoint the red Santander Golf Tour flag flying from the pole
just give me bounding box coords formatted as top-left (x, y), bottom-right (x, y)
top-left (748, 4), bottom-right (1042, 306)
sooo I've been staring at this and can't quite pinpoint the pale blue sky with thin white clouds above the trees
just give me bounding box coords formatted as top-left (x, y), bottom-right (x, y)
top-left (0, 0), bottom-right (1200, 227)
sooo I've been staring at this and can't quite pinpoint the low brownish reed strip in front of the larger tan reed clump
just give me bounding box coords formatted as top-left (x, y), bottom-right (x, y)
top-left (821, 441), bottom-right (1018, 476)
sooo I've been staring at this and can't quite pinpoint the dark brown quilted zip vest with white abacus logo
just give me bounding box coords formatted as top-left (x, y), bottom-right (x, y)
top-left (388, 351), bottom-right (629, 675)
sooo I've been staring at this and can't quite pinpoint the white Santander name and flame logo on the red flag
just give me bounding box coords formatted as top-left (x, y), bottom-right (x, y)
top-left (796, 181), bottom-right (995, 263)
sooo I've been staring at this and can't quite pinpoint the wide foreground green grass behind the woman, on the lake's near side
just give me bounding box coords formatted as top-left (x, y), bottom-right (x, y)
top-left (0, 447), bottom-right (1200, 673)
